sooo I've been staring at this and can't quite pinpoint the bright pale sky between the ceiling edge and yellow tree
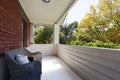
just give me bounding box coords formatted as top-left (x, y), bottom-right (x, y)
top-left (63, 0), bottom-right (99, 24)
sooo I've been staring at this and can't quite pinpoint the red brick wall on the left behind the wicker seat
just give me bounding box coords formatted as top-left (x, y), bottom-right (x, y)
top-left (0, 0), bottom-right (29, 54)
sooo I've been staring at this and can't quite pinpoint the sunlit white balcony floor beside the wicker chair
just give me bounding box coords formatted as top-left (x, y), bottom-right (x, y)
top-left (41, 56), bottom-right (82, 80)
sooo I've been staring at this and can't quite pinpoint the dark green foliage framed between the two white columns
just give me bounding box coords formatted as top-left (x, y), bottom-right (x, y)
top-left (34, 26), bottom-right (53, 44)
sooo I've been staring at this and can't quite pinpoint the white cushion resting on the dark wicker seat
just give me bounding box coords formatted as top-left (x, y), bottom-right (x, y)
top-left (15, 54), bottom-right (30, 64)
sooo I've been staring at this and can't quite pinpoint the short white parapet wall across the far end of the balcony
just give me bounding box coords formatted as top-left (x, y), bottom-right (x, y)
top-left (27, 44), bottom-right (56, 56)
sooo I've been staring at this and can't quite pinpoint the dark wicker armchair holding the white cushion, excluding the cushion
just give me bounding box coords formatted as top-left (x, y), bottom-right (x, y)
top-left (5, 48), bottom-right (41, 80)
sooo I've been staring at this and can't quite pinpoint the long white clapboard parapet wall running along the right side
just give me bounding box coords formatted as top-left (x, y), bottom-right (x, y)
top-left (58, 45), bottom-right (120, 80)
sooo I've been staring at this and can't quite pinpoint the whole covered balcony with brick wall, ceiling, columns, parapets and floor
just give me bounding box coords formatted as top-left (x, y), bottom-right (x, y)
top-left (0, 0), bottom-right (120, 80)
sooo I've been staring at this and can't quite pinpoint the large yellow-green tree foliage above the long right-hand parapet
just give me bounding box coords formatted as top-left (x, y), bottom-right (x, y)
top-left (60, 0), bottom-right (120, 48)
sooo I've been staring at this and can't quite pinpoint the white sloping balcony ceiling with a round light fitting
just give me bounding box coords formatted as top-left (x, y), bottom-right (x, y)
top-left (19, 0), bottom-right (77, 25)
